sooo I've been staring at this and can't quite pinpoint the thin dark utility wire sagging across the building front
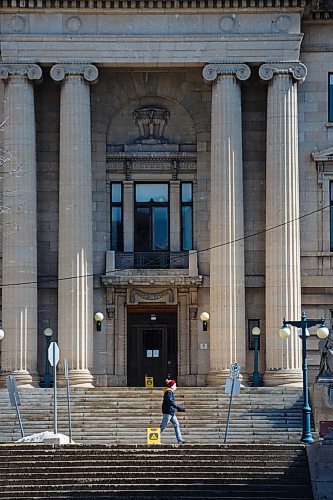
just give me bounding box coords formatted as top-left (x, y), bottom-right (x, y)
top-left (1, 201), bottom-right (331, 288)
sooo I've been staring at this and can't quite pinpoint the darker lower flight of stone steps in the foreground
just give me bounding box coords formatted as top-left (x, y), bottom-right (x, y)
top-left (0, 443), bottom-right (313, 500)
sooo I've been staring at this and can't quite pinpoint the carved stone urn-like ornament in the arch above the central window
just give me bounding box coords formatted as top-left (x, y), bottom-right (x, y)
top-left (133, 106), bottom-right (170, 144)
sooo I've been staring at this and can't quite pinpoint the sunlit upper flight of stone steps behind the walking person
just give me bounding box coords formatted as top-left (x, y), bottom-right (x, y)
top-left (0, 387), bottom-right (302, 444)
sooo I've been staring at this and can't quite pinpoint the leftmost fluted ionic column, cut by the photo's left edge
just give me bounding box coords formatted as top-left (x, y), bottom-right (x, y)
top-left (0, 64), bottom-right (42, 386)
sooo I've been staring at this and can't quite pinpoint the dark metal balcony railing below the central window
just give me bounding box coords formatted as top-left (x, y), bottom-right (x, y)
top-left (115, 252), bottom-right (189, 269)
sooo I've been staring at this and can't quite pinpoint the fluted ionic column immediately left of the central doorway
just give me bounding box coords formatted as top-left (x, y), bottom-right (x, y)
top-left (50, 64), bottom-right (98, 386)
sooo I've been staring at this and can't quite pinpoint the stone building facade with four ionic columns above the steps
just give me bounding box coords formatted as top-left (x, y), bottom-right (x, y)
top-left (0, 0), bottom-right (333, 386)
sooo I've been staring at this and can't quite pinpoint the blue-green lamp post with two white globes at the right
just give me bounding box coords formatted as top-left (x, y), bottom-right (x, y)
top-left (279, 312), bottom-right (329, 444)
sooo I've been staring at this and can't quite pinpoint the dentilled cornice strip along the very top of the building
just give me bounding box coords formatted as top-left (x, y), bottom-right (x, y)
top-left (0, 0), bottom-right (306, 13)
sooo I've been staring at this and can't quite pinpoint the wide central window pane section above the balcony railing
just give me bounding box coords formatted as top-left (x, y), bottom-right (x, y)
top-left (134, 183), bottom-right (169, 252)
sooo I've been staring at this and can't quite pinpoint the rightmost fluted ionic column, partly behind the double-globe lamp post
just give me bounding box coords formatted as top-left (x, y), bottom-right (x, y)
top-left (259, 63), bottom-right (306, 385)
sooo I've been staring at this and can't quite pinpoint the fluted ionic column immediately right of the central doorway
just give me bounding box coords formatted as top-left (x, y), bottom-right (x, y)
top-left (203, 64), bottom-right (250, 385)
